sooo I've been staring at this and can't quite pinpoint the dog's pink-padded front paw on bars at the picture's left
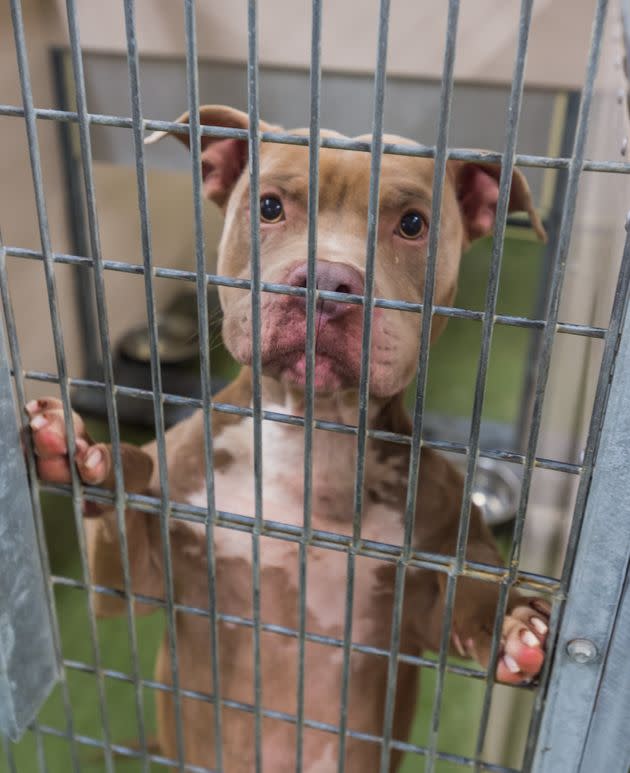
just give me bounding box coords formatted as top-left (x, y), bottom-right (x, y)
top-left (26, 397), bottom-right (110, 486)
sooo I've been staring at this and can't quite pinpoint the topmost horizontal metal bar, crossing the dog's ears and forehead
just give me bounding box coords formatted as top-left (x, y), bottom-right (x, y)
top-left (0, 104), bottom-right (630, 174)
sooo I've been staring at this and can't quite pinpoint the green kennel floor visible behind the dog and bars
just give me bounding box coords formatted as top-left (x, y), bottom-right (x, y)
top-left (0, 231), bottom-right (541, 773)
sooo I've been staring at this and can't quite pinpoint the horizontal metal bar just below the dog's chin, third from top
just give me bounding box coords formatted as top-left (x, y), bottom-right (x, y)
top-left (14, 370), bottom-right (582, 475)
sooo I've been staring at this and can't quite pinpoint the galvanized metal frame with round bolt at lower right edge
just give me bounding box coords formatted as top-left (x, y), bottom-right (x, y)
top-left (533, 231), bottom-right (630, 773)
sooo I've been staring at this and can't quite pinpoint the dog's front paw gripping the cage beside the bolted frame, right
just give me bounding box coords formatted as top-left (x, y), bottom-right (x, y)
top-left (496, 598), bottom-right (551, 684)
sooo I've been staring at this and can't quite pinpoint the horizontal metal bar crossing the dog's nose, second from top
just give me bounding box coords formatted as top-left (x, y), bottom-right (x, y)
top-left (6, 247), bottom-right (606, 338)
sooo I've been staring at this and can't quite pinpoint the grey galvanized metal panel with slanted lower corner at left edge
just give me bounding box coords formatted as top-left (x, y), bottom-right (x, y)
top-left (0, 316), bottom-right (58, 740)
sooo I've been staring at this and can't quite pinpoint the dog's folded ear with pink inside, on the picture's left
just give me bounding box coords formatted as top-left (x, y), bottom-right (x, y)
top-left (145, 105), bottom-right (276, 208)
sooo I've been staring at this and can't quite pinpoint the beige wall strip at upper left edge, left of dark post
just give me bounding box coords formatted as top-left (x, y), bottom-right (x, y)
top-left (0, 0), bottom-right (80, 394)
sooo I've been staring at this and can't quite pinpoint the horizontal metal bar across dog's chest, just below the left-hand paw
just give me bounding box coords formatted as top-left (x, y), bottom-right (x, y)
top-left (41, 483), bottom-right (560, 594)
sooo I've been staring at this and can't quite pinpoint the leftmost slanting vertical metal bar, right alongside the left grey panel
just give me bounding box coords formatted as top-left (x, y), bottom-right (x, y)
top-left (0, 233), bottom-right (80, 773)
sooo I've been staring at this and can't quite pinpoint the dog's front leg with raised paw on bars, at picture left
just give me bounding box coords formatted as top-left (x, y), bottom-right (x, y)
top-left (26, 398), bottom-right (163, 617)
